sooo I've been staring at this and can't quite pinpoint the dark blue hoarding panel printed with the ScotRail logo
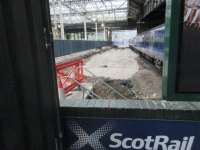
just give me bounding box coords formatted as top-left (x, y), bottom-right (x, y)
top-left (63, 118), bottom-right (200, 150)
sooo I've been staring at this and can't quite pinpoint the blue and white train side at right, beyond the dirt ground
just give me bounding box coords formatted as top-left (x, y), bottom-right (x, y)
top-left (129, 25), bottom-right (165, 61)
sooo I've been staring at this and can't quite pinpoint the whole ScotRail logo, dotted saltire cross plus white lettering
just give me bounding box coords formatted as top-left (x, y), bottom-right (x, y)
top-left (69, 121), bottom-right (195, 150)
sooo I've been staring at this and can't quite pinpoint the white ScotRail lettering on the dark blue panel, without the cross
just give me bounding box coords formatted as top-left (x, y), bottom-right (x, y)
top-left (109, 133), bottom-right (195, 150)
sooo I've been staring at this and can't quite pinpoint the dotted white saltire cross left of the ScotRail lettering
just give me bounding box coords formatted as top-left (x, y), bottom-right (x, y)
top-left (68, 121), bottom-right (113, 150)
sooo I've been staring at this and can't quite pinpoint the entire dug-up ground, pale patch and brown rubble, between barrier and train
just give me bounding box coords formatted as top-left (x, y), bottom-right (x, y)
top-left (59, 48), bottom-right (162, 100)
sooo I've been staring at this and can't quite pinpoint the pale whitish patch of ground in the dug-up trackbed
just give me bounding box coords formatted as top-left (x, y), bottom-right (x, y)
top-left (84, 48), bottom-right (139, 80)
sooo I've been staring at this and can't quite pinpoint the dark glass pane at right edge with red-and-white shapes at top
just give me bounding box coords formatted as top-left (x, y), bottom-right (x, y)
top-left (177, 0), bottom-right (200, 92)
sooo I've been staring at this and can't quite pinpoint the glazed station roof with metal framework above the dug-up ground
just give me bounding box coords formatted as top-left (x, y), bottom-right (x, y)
top-left (49, 0), bottom-right (144, 27)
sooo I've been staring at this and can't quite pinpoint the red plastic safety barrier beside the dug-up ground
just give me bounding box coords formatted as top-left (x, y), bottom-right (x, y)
top-left (56, 59), bottom-right (84, 94)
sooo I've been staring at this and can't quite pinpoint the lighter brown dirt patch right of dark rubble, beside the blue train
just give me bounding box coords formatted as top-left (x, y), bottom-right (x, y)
top-left (131, 57), bottom-right (162, 100)
